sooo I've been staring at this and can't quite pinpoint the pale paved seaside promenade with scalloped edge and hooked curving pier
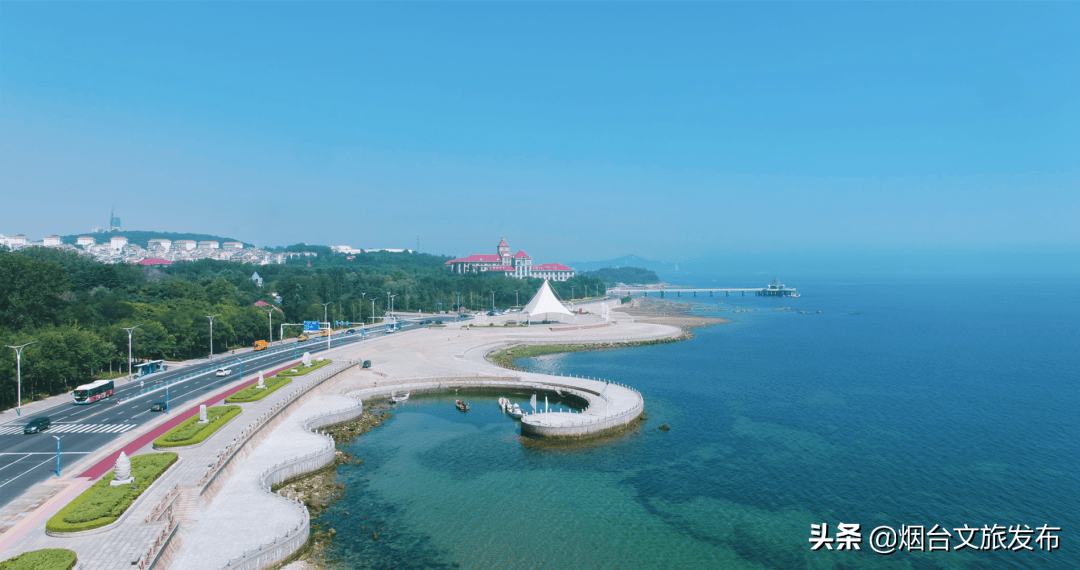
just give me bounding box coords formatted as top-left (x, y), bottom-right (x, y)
top-left (0, 300), bottom-right (681, 570)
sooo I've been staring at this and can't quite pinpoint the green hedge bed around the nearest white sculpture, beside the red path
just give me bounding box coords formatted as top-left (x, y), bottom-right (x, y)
top-left (46, 451), bottom-right (177, 531)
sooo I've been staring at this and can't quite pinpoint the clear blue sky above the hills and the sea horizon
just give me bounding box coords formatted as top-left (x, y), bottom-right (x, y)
top-left (0, 2), bottom-right (1080, 273)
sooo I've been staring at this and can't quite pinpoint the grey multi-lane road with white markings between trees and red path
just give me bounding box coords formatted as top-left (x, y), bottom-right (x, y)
top-left (0, 324), bottom-right (419, 507)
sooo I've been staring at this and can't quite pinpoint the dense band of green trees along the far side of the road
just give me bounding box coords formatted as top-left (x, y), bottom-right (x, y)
top-left (0, 246), bottom-right (605, 408)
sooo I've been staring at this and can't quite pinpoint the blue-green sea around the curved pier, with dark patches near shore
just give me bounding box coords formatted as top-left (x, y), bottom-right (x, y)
top-left (313, 276), bottom-right (1080, 570)
